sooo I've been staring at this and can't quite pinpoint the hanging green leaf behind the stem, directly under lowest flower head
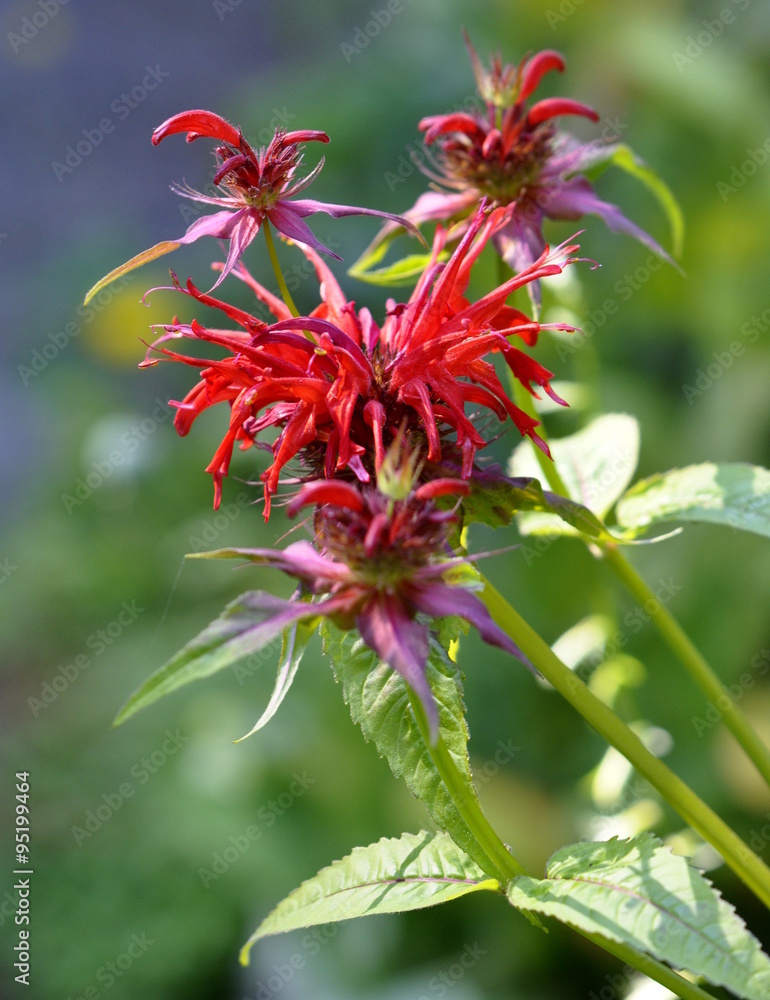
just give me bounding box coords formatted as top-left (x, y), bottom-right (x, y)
top-left (321, 621), bottom-right (489, 865)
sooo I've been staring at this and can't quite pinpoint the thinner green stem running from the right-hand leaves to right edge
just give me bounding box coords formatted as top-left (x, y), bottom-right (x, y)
top-left (601, 542), bottom-right (770, 784)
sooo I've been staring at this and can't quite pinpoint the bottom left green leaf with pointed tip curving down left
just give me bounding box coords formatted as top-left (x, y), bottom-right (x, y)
top-left (241, 831), bottom-right (500, 965)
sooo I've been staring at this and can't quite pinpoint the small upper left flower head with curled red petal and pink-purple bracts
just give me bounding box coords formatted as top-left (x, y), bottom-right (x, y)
top-left (86, 110), bottom-right (422, 302)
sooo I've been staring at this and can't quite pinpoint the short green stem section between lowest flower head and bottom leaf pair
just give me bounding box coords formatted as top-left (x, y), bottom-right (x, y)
top-left (408, 688), bottom-right (528, 886)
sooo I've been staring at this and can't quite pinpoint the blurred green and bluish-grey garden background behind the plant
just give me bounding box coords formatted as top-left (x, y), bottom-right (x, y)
top-left (0, 0), bottom-right (770, 1000)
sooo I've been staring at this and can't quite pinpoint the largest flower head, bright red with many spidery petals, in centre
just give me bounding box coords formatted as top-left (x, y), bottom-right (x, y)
top-left (144, 207), bottom-right (577, 517)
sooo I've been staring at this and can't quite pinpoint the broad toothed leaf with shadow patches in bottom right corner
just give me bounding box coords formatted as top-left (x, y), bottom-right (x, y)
top-left (508, 833), bottom-right (770, 1000)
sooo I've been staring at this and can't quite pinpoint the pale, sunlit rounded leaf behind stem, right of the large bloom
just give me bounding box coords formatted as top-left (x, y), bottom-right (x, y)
top-left (510, 413), bottom-right (639, 541)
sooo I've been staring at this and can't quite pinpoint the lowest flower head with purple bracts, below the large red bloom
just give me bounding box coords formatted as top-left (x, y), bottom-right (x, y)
top-left (207, 464), bottom-right (529, 738)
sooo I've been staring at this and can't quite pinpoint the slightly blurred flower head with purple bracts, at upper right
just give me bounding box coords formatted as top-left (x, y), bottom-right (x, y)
top-left (369, 37), bottom-right (671, 305)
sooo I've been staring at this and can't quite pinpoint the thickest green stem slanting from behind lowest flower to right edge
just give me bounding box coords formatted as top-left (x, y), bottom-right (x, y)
top-left (481, 577), bottom-right (770, 906)
